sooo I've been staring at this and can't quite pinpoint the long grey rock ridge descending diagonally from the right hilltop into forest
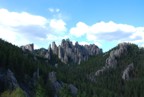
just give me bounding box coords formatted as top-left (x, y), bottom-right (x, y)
top-left (95, 43), bottom-right (130, 76)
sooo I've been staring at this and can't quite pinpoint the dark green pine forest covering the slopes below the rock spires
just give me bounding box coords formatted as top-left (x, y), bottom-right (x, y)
top-left (0, 39), bottom-right (144, 97)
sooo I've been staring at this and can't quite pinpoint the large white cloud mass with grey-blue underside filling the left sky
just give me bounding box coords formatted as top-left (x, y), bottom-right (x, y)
top-left (0, 9), bottom-right (67, 46)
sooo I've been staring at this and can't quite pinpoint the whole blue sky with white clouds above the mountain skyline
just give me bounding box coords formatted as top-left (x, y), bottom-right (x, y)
top-left (0, 0), bottom-right (144, 52)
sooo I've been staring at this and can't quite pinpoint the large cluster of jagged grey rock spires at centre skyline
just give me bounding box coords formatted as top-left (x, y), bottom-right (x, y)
top-left (52, 39), bottom-right (102, 64)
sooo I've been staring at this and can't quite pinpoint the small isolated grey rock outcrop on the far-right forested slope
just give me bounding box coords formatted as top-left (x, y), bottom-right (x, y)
top-left (122, 63), bottom-right (134, 80)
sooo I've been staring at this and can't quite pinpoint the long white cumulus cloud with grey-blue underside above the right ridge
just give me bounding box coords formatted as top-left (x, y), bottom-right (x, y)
top-left (70, 21), bottom-right (144, 44)
